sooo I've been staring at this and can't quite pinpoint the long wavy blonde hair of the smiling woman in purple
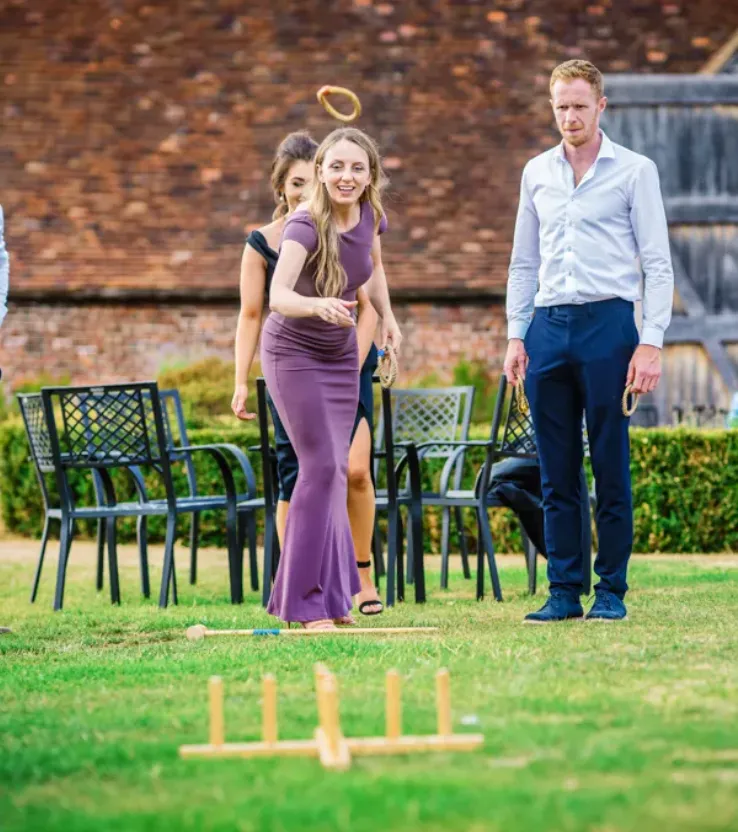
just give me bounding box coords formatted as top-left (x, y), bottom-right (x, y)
top-left (308, 127), bottom-right (387, 298)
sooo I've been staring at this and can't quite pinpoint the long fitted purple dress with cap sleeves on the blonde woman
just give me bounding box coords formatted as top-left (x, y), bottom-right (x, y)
top-left (261, 202), bottom-right (387, 621)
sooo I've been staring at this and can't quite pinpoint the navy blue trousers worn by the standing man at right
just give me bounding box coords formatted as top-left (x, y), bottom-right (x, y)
top-left (525, 298), bottom-right (638, 598)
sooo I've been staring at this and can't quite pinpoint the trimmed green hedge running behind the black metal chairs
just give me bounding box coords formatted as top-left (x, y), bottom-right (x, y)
top-left (0, 420), bottom-right (738, 553)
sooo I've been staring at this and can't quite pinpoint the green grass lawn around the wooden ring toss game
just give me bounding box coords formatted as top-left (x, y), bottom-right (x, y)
top-left (0, 541), bottom-right (738, 832)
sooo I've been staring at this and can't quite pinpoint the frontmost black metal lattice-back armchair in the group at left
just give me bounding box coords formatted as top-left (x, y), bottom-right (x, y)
top-left (41, 382), bottom-right (243, 610)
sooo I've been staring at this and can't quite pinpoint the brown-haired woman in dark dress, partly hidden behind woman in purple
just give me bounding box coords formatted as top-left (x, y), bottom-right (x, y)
top-left (231, 131), bottom-right (382, 624)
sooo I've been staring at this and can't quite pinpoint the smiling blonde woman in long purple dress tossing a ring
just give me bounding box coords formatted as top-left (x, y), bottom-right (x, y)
top-left (261, 127), bottom-right (401, 629)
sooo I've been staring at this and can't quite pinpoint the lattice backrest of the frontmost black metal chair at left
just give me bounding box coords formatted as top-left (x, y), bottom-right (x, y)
top-left (41, 382), bottom-right (168, 469)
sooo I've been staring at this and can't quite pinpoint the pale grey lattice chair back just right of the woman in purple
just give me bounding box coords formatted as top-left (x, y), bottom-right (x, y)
top-left (375, 386), bottom-right (474, 458)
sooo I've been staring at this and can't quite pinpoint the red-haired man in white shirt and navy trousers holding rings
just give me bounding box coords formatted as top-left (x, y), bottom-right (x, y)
top-left (504, 60), bottom-right (674, 623)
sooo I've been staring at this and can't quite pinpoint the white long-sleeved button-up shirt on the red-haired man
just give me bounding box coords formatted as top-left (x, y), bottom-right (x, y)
top-left (507, 133), bottom-right (674, 347)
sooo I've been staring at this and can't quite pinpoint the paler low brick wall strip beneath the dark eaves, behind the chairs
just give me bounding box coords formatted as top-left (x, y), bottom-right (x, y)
top-left (0, 303), bottom-right (505, 384)
